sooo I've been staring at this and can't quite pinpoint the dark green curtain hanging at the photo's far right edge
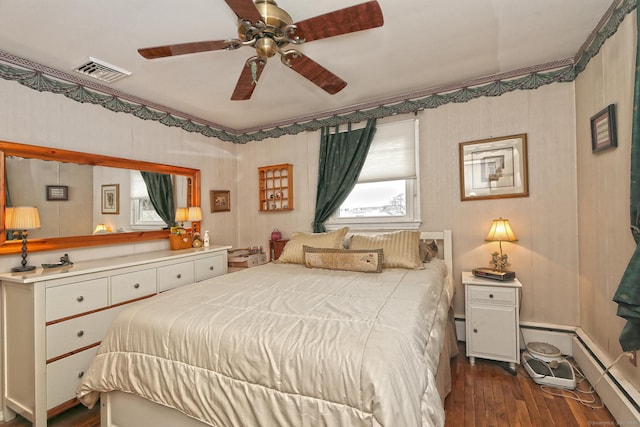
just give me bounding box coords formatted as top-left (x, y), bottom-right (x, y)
top-left (613, 0), bottom-right (640, 351)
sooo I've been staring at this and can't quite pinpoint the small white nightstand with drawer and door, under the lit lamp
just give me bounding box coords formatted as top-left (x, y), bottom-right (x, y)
top-left (462, 272), bottom-right (522, 370)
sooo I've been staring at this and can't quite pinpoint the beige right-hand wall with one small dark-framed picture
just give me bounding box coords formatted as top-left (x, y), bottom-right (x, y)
top-left (576, 13), bottom-right (640, 382)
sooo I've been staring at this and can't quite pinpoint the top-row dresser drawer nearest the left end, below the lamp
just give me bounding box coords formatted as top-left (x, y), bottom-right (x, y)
top-left (46, 277), bottom-right (109, 322)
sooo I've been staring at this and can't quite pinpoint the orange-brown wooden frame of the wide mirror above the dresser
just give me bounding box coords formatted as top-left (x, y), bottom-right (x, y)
top-left (0, 141), bottom-right (200, 255)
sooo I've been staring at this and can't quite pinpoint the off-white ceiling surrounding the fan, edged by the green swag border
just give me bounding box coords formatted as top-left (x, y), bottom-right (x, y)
top-left (0, 0), bottom-right (617, 131)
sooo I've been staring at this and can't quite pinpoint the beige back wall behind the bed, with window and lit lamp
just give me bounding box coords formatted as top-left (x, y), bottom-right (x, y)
top-left (238, 83), bottom-right (579, 325)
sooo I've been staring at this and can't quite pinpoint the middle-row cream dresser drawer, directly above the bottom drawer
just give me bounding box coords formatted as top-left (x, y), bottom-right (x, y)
top-left (47, 305), bottom-right (126, 360)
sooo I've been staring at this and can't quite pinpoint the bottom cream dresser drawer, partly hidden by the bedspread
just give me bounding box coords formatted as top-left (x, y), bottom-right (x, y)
top-left (47, 346), bottom-right (99, 409)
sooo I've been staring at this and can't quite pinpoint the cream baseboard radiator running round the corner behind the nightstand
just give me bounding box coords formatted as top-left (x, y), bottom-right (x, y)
top-left (456, 318), bottom-right (640, 425)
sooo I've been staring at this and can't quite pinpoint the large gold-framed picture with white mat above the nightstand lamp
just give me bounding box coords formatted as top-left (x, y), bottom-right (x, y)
top-left (460, 134), bottom-right (529, 201)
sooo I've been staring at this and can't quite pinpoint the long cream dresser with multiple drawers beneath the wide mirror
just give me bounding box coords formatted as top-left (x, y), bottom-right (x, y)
top-left (0, 246), bottom-right (230, 427)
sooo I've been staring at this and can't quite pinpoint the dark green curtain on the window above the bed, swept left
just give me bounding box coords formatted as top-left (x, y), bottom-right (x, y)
top-left (313, 119), bottom-right (376, 233)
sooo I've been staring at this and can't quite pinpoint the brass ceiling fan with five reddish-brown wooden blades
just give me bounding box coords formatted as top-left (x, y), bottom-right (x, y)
top-left (138, 0), bottom-right (384, 100)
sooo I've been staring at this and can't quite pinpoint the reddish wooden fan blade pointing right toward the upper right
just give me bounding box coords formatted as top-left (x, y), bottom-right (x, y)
top-left (290, 1), bottom-right (384, 42)
